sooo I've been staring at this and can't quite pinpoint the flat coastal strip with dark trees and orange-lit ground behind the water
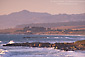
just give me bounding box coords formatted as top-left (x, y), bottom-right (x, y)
top-left (0, 26), bottom-right (85, 35)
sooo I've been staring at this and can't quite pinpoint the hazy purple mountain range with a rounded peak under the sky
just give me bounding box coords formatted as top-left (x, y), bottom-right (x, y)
top-left (0, 10), bottom-right (85, 29)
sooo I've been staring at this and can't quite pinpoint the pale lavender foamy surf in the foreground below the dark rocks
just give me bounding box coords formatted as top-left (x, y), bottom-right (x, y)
top-left (0, 47), bottom-right (85, 57)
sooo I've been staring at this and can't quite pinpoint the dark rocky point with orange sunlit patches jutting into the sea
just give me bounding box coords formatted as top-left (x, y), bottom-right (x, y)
top-left (3, 40), bottom-right (85, 51)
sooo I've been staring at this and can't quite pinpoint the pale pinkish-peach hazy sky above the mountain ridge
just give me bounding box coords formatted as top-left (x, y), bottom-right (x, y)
top-left (0, 0), bottom-right (85, 15)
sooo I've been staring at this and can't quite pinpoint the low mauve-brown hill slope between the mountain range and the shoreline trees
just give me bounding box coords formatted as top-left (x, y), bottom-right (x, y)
top-left (16, 21), bottom-right (85, 29)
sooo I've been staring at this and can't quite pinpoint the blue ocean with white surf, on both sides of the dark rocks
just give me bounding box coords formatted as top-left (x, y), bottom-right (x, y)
top-left (0, 34), bottom-right (85, 57)
